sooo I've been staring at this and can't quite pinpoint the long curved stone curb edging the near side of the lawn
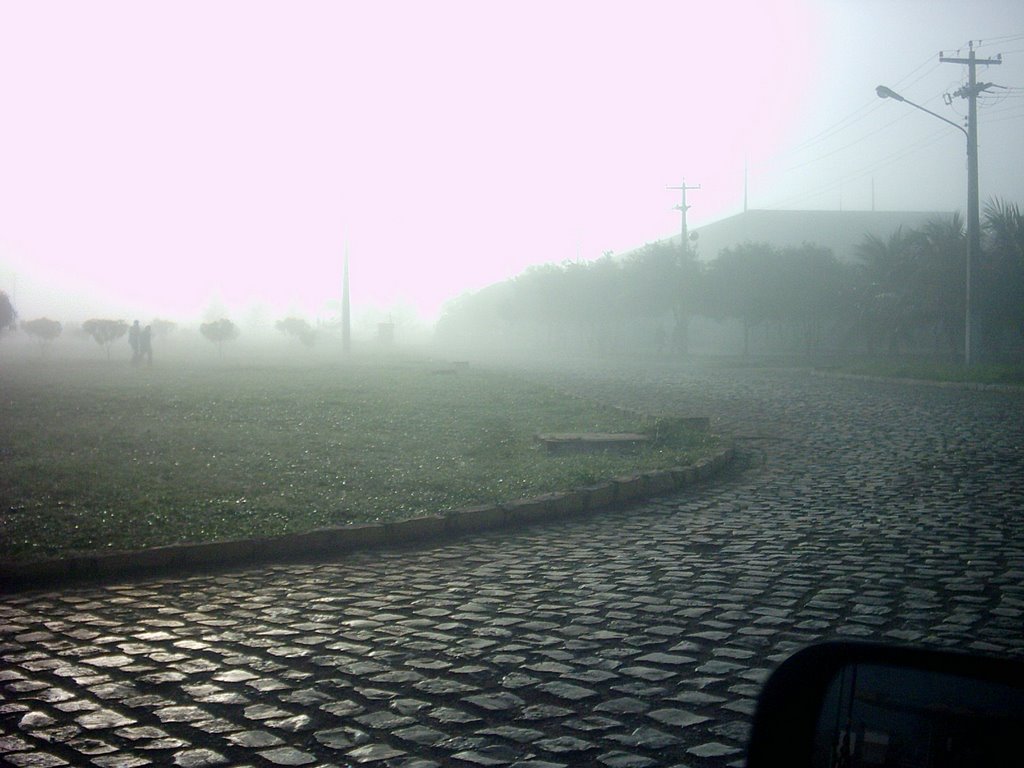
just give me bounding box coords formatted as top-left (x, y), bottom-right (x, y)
top-left (0, 445), bottom-right (736, 593)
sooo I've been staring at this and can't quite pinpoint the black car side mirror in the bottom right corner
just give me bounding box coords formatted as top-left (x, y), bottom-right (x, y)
top-left (746, 642), bottom-right (1024, 768)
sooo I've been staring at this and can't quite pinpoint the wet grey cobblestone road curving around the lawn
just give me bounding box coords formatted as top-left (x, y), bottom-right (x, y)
top-left (0, 367), bottom-right (1024, 768)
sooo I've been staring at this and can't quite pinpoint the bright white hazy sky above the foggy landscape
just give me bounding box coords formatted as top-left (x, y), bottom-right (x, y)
top-left (0, 0), bottom-right (1024, 322)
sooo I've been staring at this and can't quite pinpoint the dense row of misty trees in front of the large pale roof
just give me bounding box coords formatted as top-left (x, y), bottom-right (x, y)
top-left (437, 201), bottom-right (1024, 359)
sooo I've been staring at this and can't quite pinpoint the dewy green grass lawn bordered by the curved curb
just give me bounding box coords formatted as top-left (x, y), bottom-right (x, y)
top-left (0, 360), bottom-right (716, 562)
